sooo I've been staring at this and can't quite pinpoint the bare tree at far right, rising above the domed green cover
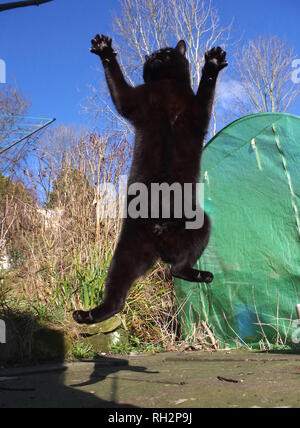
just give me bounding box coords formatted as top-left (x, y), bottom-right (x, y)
top-left (237, 37), bottom-right (300, 114)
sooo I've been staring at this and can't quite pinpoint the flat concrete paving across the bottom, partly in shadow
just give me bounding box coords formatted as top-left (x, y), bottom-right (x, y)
top-left (0, 352), bottom-right (300, 408)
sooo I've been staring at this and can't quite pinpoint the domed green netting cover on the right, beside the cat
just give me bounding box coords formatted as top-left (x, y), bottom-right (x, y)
top-left (175, 114), bottom-right (300, 348)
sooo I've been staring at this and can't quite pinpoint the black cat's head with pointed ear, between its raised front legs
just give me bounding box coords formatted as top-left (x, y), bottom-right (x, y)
top-left (143, 40), bottom-right (190, 83)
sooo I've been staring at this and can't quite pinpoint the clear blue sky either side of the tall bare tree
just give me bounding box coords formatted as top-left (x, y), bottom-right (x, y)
top-left (0, 0), bottom-right (300, 129)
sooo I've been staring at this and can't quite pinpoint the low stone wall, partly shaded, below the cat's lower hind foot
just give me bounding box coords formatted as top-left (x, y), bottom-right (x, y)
top-left (0, 314), bottom-right (128, 365)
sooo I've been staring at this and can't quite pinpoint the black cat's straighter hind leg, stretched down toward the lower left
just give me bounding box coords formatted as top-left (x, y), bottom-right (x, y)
top-left (73, 222), bottom-right (158, 324)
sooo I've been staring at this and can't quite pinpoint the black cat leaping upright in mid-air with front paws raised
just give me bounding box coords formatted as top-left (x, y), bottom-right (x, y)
top-left (73, 35), bottom-right (228, 324)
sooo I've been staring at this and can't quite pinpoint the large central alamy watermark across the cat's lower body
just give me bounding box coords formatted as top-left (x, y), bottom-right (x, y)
top-left (95, 175), bottom-right (204, 230)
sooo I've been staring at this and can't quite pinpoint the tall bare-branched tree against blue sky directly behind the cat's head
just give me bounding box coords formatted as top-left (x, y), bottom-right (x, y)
top-left (89, 0), bottom-right (232, 136)
